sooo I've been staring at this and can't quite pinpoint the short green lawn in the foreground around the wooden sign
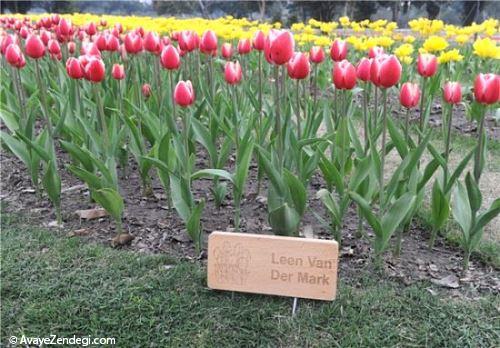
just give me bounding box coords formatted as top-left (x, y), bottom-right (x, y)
top-left (0, 217), bottom-right (500, 347)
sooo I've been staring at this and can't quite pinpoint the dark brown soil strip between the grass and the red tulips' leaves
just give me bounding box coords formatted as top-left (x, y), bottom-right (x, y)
top-left (0, 123), bottom-right (500, 297)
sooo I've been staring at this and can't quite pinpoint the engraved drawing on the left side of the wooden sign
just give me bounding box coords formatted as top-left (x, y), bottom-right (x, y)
top-left (214, 242), bottom-right (251, 285)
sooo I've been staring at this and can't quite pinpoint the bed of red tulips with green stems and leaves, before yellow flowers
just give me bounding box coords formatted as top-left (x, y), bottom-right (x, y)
top-left (0, 14), bottom-right (500, 267)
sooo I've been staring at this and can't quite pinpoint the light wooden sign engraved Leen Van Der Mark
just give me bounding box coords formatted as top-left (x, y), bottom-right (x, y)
top-left (208, 232), bottom-right (339, 301)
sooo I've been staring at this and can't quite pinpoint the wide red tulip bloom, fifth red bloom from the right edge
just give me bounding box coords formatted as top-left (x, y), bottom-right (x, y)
top-left (370, 54), bottom-right (402, 88)
